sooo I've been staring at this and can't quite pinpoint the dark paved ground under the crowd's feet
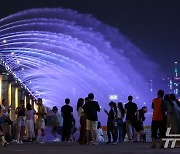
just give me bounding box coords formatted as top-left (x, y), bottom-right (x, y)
top-left (0, 142), bottom-right (180, 154)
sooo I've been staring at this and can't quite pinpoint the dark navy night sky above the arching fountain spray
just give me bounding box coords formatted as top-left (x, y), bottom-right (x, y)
top-left (0, 0), bottom-right (180, 75)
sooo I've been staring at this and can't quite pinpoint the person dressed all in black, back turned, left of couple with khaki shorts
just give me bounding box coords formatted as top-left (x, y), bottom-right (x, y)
top-left (61, 98), bottom-right (73, 142)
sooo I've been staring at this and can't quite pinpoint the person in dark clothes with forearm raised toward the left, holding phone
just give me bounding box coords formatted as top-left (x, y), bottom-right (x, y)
top-left (104, 102), bottom-right (116, 145)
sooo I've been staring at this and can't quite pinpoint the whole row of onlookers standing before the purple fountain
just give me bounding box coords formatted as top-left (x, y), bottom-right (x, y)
top-left (0, 90), bottom-right (180, 148)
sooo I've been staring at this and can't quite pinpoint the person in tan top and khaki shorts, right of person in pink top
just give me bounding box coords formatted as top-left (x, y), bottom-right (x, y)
top-left (35, 98), bottom-right (47, 143)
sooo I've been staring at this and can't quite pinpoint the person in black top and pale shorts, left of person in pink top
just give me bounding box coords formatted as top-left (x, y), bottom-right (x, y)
top-left (15, 100), bottom-right (26, 144)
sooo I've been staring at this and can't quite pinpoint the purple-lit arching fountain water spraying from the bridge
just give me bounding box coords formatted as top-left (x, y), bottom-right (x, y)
top-left (0, 8), bottom-right (159, 124)
